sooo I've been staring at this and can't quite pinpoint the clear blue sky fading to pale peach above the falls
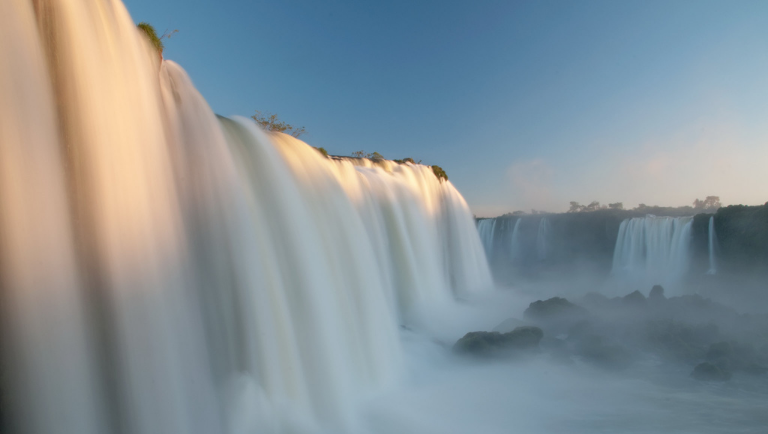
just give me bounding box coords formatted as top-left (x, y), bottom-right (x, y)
top-left (124, 0), bottom-right (768, 216)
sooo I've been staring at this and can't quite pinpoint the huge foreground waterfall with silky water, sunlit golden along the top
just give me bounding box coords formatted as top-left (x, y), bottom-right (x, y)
top-left (0, 0), bottom-right (492, 434)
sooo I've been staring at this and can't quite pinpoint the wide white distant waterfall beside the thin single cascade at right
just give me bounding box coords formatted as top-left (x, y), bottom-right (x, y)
top-left (612, 215), bottom-right (693, 287)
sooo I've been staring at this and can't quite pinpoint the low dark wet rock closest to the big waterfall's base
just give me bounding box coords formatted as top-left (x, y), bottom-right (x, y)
top-left (453, 326), bottom-right (544, 356)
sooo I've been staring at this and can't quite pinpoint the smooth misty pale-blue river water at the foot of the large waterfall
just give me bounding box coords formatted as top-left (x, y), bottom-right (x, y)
top-left (361, 291), bottom-right (768, 434)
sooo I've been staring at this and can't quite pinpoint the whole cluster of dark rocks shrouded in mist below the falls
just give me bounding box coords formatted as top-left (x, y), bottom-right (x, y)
top-left (454, 285), bottom-right (768, 384)
